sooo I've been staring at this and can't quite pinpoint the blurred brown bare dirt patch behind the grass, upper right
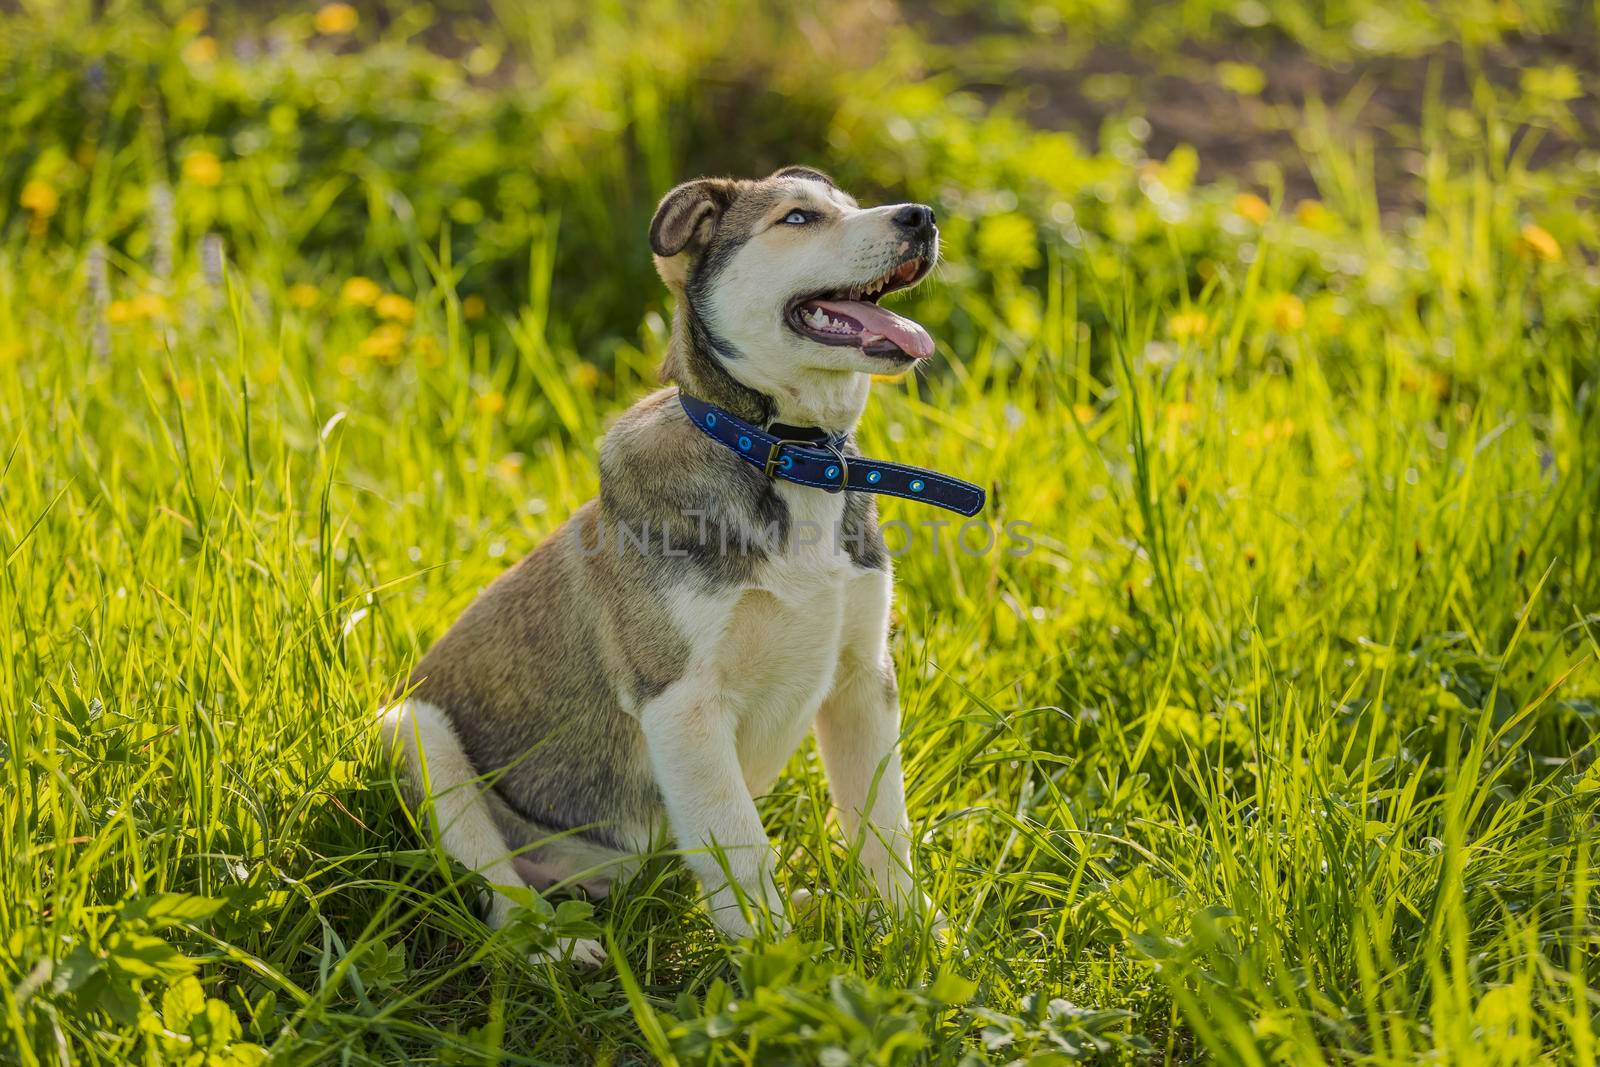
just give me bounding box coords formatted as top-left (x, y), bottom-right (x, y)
top-left (902, 3), bottom-right (1600, 214)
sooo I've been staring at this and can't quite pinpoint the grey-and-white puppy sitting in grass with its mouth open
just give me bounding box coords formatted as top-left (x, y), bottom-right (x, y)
top-left (382, 166), bottom-right (982, 965)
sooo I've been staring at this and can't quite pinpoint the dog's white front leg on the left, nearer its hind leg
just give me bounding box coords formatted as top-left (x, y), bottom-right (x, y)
top-left (640, 678), bottom-right (782, 937)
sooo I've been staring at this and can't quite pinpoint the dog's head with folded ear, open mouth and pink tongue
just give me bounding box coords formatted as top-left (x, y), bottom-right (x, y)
top-left (650, 166), bottom-right (939, 419)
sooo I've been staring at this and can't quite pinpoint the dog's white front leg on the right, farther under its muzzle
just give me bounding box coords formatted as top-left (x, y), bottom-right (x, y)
top-left (816, 648), bottom-right (922, 909)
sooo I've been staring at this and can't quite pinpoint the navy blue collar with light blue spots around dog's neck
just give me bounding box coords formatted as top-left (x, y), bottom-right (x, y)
top-left (678, 389), bottom-right (984, 515)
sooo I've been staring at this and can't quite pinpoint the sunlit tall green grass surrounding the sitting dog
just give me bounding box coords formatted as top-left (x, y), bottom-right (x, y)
top-left (0, 3), bottom-right (1600, 1065)
